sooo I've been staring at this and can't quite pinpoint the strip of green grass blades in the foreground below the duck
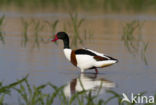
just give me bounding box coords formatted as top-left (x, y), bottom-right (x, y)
top-left (0, 76), bottom-right (156, 105)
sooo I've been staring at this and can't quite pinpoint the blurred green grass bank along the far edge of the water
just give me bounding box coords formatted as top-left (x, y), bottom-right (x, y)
top-left (0, 0), bottom-right (156, 12)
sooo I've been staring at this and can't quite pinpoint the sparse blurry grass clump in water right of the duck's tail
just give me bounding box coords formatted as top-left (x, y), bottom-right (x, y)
top-left (121, 20), bottom-right (148, 65)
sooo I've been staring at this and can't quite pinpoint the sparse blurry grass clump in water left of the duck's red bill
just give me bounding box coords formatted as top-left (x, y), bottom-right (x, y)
top-left (21, 18), bottom-right (59, 48)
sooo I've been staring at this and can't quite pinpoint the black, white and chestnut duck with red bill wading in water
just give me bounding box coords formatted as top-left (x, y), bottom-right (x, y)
top-left (51, 32), bottom-right (118, 74)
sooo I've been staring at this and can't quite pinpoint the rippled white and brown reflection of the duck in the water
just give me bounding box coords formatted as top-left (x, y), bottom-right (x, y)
top-left (64, 74), bottom-right (115, 97)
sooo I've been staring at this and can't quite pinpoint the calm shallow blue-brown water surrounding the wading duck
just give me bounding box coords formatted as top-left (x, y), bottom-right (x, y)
top-left (0, 13), bottom-right (156, 104)
